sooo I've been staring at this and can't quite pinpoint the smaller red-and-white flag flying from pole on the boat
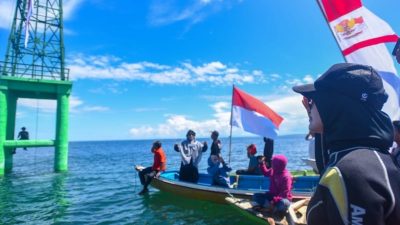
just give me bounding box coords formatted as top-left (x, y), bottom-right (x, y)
top-left (231, 86), bottom-right (283, 139)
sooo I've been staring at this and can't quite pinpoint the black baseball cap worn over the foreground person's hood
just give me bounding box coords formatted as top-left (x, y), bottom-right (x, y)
top-left (293, 63), bottom-right (388, 109)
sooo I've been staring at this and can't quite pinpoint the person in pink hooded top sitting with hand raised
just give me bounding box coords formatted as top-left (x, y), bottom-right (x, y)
top-left (253, 155), bottom-right (293, 214)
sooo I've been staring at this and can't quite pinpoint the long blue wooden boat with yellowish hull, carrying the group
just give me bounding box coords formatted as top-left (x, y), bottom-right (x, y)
top-left (151, 171), bottom-right (319, 204)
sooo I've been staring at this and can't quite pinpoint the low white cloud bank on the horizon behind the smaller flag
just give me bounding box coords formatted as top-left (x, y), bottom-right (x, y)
top-left (130, 94), bottom-right (308, 139)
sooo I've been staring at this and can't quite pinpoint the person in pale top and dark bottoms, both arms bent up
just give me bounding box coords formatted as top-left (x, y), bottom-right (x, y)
top-left (174, 130), bottom-right (208, 183)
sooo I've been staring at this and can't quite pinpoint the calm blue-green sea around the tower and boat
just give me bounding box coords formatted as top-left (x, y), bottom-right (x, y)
top-left (0, 135), bottom-right (308, 225)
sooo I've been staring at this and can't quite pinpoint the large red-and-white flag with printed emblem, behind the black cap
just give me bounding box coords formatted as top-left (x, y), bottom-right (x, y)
top-left (318, 0), bottom-right (400, 120)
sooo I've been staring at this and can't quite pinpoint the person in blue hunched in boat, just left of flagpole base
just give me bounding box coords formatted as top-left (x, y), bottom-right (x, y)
top-left (207, 155), bottom-right (232, 188)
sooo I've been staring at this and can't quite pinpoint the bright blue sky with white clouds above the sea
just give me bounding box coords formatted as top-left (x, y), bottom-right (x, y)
top-left (0, 0), bottom-right (400, 140)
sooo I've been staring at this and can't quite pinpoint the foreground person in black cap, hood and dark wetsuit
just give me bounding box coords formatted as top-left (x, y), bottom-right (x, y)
top-left (293, 63), bottom-right (400, 225)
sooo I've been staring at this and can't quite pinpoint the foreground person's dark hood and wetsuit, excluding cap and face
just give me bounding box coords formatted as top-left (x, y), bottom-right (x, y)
top-left (307, 92), bottom-right (400, 225)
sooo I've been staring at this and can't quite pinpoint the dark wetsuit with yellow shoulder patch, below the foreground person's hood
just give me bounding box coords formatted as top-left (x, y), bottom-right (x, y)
top-left (307, 147), bottom-right (400, 225)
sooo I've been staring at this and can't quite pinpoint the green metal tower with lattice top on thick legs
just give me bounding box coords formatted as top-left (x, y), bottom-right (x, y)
top-left (0, 0), bottom-right (72, 175)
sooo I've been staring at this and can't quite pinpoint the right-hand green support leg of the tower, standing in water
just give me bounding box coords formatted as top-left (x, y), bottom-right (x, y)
top-left (54, 94), bottom-right (69, 172)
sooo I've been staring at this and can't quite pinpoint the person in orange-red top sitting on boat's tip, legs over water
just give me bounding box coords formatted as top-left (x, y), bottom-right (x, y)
top-left (137, 141), bottom-right (167, 195)
